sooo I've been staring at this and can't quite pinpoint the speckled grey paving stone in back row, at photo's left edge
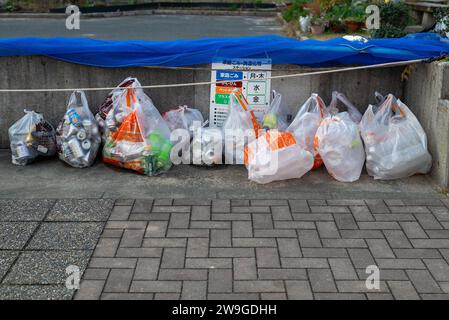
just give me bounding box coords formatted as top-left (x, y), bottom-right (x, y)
top-left (0, 199), bottom-right (55, 221)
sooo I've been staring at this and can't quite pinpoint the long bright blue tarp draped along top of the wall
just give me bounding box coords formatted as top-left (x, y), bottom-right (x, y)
top-left (0, 33), bottom-right (449, 67)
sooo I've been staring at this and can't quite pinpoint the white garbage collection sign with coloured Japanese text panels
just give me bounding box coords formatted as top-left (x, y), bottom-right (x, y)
top-left (209, 58), bottom-right (271, 127)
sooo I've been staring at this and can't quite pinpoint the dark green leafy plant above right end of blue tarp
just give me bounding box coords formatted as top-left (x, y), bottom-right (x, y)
top-left (370, 1), bottom-right (413, 38)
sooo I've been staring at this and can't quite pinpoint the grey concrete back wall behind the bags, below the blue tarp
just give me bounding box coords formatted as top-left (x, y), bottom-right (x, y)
top-left (0, 57), bottom-right (403, 148)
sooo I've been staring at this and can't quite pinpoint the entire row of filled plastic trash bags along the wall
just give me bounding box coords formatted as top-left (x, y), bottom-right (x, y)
top-left (9, 78), bottom-right (432, 184)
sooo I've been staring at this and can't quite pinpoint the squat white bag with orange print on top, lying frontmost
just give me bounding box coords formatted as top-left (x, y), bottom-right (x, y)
top-left (245, 130), bottom-right (314, 184)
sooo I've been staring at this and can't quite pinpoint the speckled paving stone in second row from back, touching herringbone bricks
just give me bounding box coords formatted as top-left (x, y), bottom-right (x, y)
top-left (27, 222), bottom-right (103, 250)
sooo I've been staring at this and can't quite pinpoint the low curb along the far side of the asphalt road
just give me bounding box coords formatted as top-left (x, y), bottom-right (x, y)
top-left (0, 9), bottom-right (278, 19)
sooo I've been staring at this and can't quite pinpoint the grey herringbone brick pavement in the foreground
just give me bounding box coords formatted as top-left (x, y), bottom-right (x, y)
top-left (70, 198), bottom-right (449, 300)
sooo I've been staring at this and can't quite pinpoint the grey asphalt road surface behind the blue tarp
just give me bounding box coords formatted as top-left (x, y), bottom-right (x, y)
top-left (0, 15), bottom-right (281, 40)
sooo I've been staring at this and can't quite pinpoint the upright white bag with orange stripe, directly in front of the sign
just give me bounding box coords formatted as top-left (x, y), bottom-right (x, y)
top-left (222, 89), bottom-right (260, 164)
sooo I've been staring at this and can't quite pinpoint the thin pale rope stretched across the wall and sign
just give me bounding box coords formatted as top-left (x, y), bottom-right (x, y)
top-left (0, 59), bottom-right (427, 93)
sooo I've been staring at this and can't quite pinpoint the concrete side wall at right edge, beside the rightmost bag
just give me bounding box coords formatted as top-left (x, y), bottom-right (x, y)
top-left (404, 62), bottom-right (449, 188)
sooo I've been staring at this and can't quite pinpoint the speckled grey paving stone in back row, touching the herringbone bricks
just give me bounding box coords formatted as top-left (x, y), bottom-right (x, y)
top-left (46, 199), bottom-right (114, 221)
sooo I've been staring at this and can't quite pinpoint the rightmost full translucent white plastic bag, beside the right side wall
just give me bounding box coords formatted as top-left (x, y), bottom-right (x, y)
top-left (360, 94), bottom-right (432, 180)
